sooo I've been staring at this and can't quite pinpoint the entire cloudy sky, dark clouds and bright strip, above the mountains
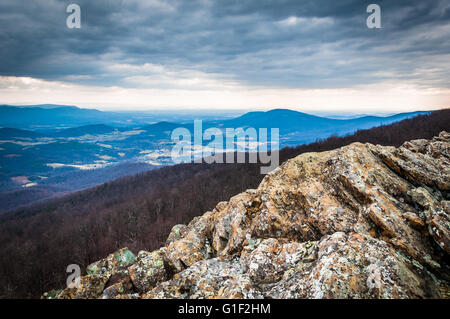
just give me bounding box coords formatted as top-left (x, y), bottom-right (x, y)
top-left (0, 0), bottom-right (450, 113)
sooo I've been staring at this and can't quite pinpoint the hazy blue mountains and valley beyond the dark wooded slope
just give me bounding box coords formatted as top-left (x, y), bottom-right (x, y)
top-left (0, 105), bottom-right (429, 215)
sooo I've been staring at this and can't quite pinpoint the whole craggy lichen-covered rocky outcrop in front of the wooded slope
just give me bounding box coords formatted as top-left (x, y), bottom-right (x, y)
top-left (43, 132), bottom-right (450, 298)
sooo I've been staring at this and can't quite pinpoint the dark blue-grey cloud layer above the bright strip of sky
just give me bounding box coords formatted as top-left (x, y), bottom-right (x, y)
top-left (0, 0), bottom-right (450, 88)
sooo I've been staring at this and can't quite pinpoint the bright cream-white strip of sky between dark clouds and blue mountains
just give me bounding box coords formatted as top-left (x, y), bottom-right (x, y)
top-left (0, 76), bottom-right (450, 113)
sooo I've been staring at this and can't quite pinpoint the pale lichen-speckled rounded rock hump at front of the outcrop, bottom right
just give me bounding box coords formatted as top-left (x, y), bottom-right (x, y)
top-left (265, 232), bottom-right (440, 298)
